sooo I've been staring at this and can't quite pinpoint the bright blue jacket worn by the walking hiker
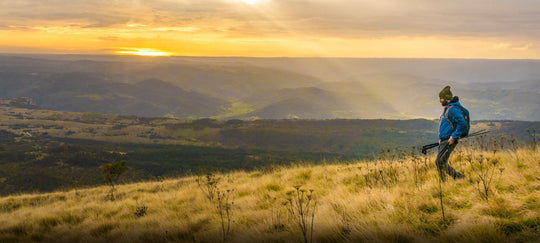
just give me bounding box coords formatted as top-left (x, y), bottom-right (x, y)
top-left (439, 101), bottom-right (467, 140)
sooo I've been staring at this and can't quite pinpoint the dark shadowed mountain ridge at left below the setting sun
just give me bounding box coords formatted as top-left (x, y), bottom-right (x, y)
top-left (0, 72), bottom-right (228, 118)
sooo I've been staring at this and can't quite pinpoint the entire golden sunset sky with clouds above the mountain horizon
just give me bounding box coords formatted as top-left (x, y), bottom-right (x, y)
top-left (0, 0), bottom-right (540, 59)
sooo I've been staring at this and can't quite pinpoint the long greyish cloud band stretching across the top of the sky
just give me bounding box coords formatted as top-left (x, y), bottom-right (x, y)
top-left (0, 0), bottom-right (540, 39)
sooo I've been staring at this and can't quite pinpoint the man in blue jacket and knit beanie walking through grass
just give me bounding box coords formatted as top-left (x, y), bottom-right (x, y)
top-left (435, 86), bottom-right (467, 181)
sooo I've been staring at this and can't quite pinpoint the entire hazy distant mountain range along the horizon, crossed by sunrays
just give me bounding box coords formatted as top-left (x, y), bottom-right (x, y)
top-left (0, 55), bottom-right (540, 121)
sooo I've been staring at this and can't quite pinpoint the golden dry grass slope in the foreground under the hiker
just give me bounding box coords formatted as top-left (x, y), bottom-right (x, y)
top-left (0, 145), bottom-right (540, 242)
